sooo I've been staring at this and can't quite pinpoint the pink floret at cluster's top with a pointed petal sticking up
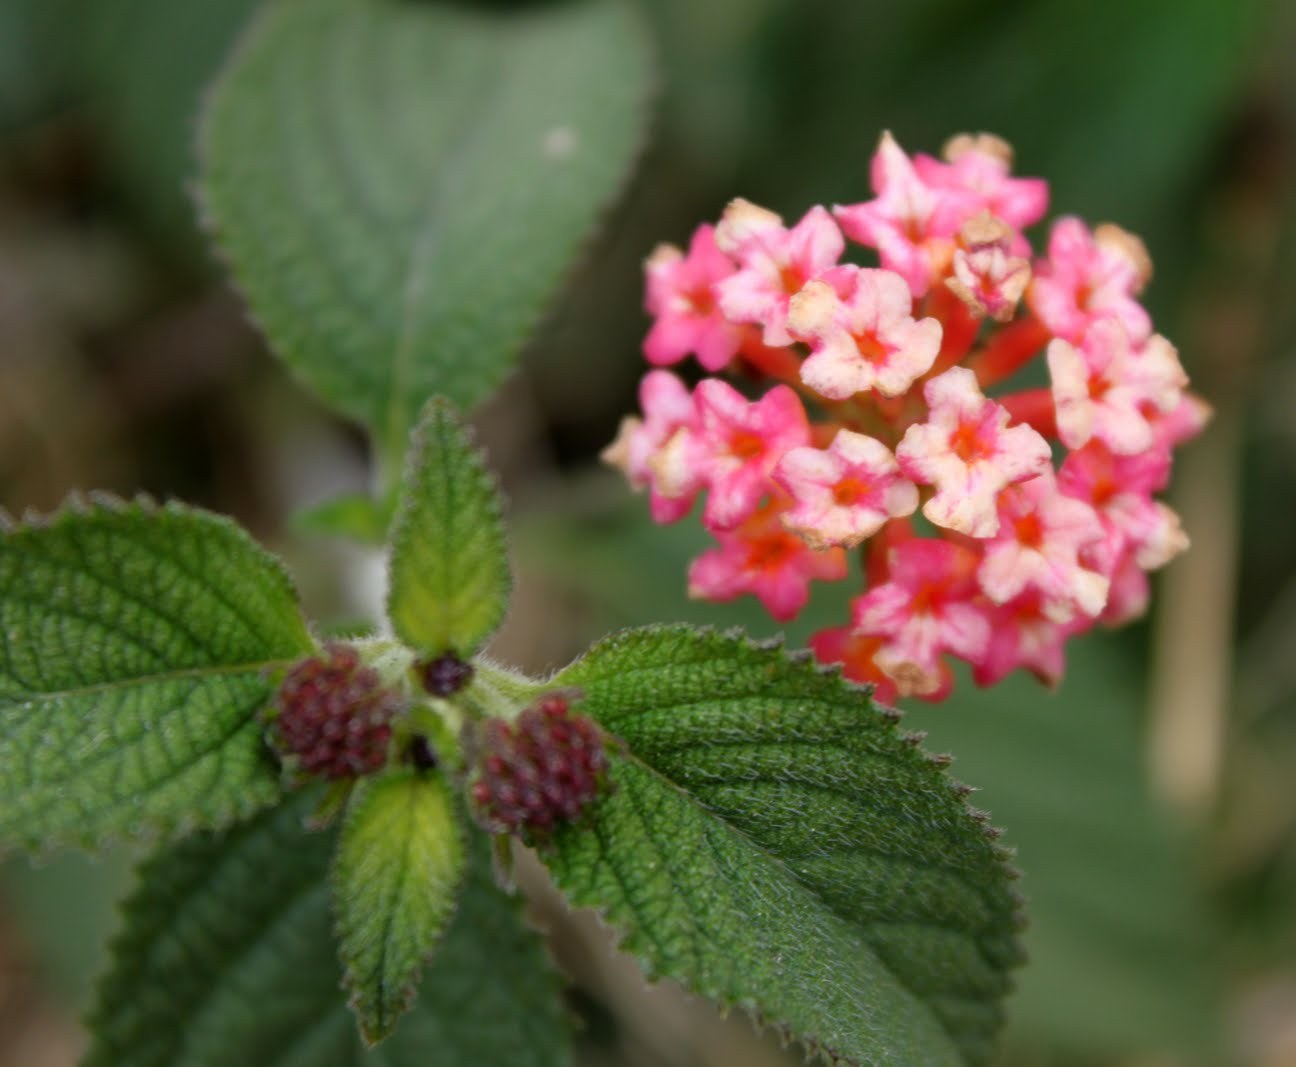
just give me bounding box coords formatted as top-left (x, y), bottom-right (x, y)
top-left (832, 131), bottom-right (953, 298)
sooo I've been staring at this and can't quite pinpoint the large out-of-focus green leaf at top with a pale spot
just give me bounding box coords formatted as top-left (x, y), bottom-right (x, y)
top-left (201, 0), bottom-right (649, 451)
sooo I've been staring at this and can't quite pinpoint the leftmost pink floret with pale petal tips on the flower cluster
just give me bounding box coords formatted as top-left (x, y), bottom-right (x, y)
top-left (601, 371), bottom-right (705, 522)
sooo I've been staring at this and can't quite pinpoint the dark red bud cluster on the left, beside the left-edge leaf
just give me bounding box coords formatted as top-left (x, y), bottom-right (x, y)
top-left (275, 643), bottom-right (403, 778)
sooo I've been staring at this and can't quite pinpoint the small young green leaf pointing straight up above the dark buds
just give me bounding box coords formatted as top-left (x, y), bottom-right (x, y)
top-left (388, 399), bottom-right (509, 656)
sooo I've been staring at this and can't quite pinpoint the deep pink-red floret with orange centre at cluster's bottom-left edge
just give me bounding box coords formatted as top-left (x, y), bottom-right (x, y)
top-left (688, 500), bottom-right (846, 622)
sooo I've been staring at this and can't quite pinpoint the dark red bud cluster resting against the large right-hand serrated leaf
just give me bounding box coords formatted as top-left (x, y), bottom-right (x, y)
top-left (472, 694), bottom-right (608, 841)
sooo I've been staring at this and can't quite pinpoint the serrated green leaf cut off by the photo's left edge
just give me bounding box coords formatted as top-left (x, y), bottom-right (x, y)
top-left (0, 498), bottom-right (312, 845)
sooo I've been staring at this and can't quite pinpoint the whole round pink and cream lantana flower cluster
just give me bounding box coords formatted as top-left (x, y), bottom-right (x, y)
top-left (605, 134), bottom-right (1209, 700)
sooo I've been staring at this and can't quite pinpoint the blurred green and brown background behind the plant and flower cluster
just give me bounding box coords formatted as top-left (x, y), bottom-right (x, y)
top-left (0, 0), bottom-right (1296, 1067)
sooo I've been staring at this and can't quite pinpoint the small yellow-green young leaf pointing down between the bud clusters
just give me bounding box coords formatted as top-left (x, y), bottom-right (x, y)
top-left (333, 770), bottom-right (464, 1044)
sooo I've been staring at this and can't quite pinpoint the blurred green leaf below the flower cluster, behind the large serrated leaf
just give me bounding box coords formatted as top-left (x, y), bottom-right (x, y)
top-left (908, 635), bottom-right (1220, 1062)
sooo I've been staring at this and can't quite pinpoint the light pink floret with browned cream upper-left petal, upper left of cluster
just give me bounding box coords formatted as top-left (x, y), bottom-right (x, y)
top-left (715, 200), bottom-right (846, 347)
